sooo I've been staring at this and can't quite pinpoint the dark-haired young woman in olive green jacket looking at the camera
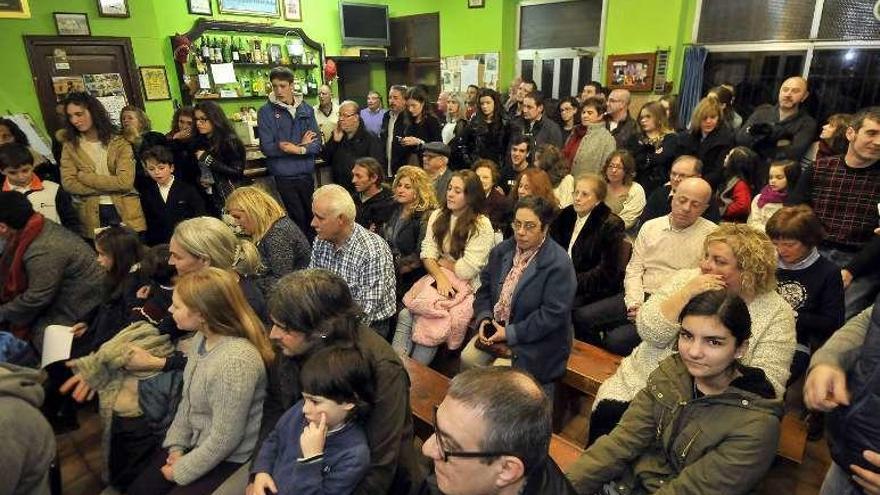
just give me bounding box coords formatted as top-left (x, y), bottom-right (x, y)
top-left (568, 290), bottom-right (782, 495)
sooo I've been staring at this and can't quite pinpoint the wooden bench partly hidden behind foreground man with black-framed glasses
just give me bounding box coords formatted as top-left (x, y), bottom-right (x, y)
top-left (402, 358), bottom-right (584, 471)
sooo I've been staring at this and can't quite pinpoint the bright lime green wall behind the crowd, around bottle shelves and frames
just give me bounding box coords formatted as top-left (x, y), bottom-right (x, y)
top-left (0, 0), bottom-right (698, 136)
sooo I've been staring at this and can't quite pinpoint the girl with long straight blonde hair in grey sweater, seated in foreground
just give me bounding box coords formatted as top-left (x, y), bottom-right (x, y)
top-left (127, 267), bottom-right (274, 495)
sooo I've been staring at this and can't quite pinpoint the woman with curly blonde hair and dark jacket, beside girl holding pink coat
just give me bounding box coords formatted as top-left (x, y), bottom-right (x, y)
top-left (384, 165), bottom-right (437, 300)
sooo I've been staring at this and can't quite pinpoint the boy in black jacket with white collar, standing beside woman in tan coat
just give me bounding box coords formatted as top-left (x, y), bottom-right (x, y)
top-left (141, 146), bottom-right (205, 246)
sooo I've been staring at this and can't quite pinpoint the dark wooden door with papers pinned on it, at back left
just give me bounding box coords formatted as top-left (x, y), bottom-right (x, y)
top-left (24, 36), bottom-right (144, 135)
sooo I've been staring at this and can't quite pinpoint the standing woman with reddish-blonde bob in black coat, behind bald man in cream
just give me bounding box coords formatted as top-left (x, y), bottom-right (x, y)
top-left (678, 98), bottom-right (736, 191)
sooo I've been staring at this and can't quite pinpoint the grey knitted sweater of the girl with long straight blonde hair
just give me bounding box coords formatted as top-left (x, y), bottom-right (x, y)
top-left (162, 333), bottom-right (266, 485)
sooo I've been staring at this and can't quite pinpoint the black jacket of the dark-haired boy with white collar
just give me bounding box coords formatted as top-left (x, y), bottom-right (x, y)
top-left (141, 177), bottom-right (206, 246)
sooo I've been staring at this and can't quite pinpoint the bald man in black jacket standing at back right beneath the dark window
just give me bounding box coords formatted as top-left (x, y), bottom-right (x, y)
top-left (736, 77), bottom-right (816, 187)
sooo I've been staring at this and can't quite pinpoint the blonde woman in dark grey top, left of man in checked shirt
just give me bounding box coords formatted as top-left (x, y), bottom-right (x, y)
top-left (226, 186), bottom-right (312, 295)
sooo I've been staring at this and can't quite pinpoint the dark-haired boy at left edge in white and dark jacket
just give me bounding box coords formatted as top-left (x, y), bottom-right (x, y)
top-left (0, 143), bottom-right (79, 233)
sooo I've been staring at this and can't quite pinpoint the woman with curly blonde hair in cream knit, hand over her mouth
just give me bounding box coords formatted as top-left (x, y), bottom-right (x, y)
top-left (589, 223), bottom-right (796, 444)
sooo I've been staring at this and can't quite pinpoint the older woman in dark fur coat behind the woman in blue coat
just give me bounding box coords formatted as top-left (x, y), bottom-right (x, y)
top-left (550, 174), bottom-right (626, 310)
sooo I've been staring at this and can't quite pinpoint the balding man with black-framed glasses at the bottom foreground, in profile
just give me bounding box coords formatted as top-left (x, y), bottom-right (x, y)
top-left (420, 366), bottom-right (575, 495)
